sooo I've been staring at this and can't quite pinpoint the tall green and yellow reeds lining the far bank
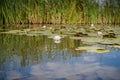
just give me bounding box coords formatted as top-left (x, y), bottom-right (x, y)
top-left (0, 0), bottom-right (120, 25)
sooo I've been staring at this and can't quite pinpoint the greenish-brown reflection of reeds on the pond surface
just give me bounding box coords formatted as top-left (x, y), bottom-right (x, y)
top-left (0, 34), bottom-right (81, 66)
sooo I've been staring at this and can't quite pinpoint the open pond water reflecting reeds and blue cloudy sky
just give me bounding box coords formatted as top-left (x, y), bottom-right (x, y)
top-left (0, 24), bottom-right (120, 80)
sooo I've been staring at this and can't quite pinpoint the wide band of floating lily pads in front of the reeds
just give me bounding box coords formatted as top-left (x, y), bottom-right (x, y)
top-left (0, 25), bottom-right (120, 51)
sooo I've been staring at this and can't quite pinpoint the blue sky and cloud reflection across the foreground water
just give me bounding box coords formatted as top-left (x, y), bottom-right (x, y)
top-left (0, 49), bottom-right (120, 80)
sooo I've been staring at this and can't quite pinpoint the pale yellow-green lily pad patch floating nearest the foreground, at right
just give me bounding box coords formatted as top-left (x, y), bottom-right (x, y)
top-left (75, 46), bottom-right (109, 53)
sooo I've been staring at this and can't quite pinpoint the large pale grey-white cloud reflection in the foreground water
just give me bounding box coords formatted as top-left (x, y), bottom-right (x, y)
top-left (28, 62), bottom-right (120, 80)
